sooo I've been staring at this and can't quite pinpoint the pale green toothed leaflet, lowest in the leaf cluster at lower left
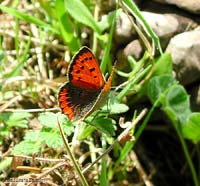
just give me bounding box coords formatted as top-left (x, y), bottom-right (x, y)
top-left (12, 141), bottom-right (41, 155)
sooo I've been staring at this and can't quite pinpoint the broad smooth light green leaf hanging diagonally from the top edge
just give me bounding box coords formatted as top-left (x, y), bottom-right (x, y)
top-left (65, 0), bottom-right (102, 34)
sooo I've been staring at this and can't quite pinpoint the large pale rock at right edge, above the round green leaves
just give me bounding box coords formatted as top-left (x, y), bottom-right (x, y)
top-left (166, 29), bottom-right (200, 85)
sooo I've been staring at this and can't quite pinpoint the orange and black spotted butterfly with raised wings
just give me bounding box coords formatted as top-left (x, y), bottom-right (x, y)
top-left (58, 46), bottom-right (114, 121)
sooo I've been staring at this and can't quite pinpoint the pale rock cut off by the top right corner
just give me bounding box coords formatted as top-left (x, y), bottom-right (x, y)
top-left (155, 0), bottom-right (200, 14)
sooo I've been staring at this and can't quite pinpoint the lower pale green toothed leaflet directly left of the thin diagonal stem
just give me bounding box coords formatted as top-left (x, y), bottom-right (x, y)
top-left (39, 132), bottom-right (63, 148)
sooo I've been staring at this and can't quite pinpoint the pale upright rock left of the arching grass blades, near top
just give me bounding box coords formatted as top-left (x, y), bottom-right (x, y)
top-left (114, 12), bottom-right (136, 45)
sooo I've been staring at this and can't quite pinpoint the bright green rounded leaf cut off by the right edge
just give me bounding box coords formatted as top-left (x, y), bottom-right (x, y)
top-left (182, 113), bottom-right (200, 142)
